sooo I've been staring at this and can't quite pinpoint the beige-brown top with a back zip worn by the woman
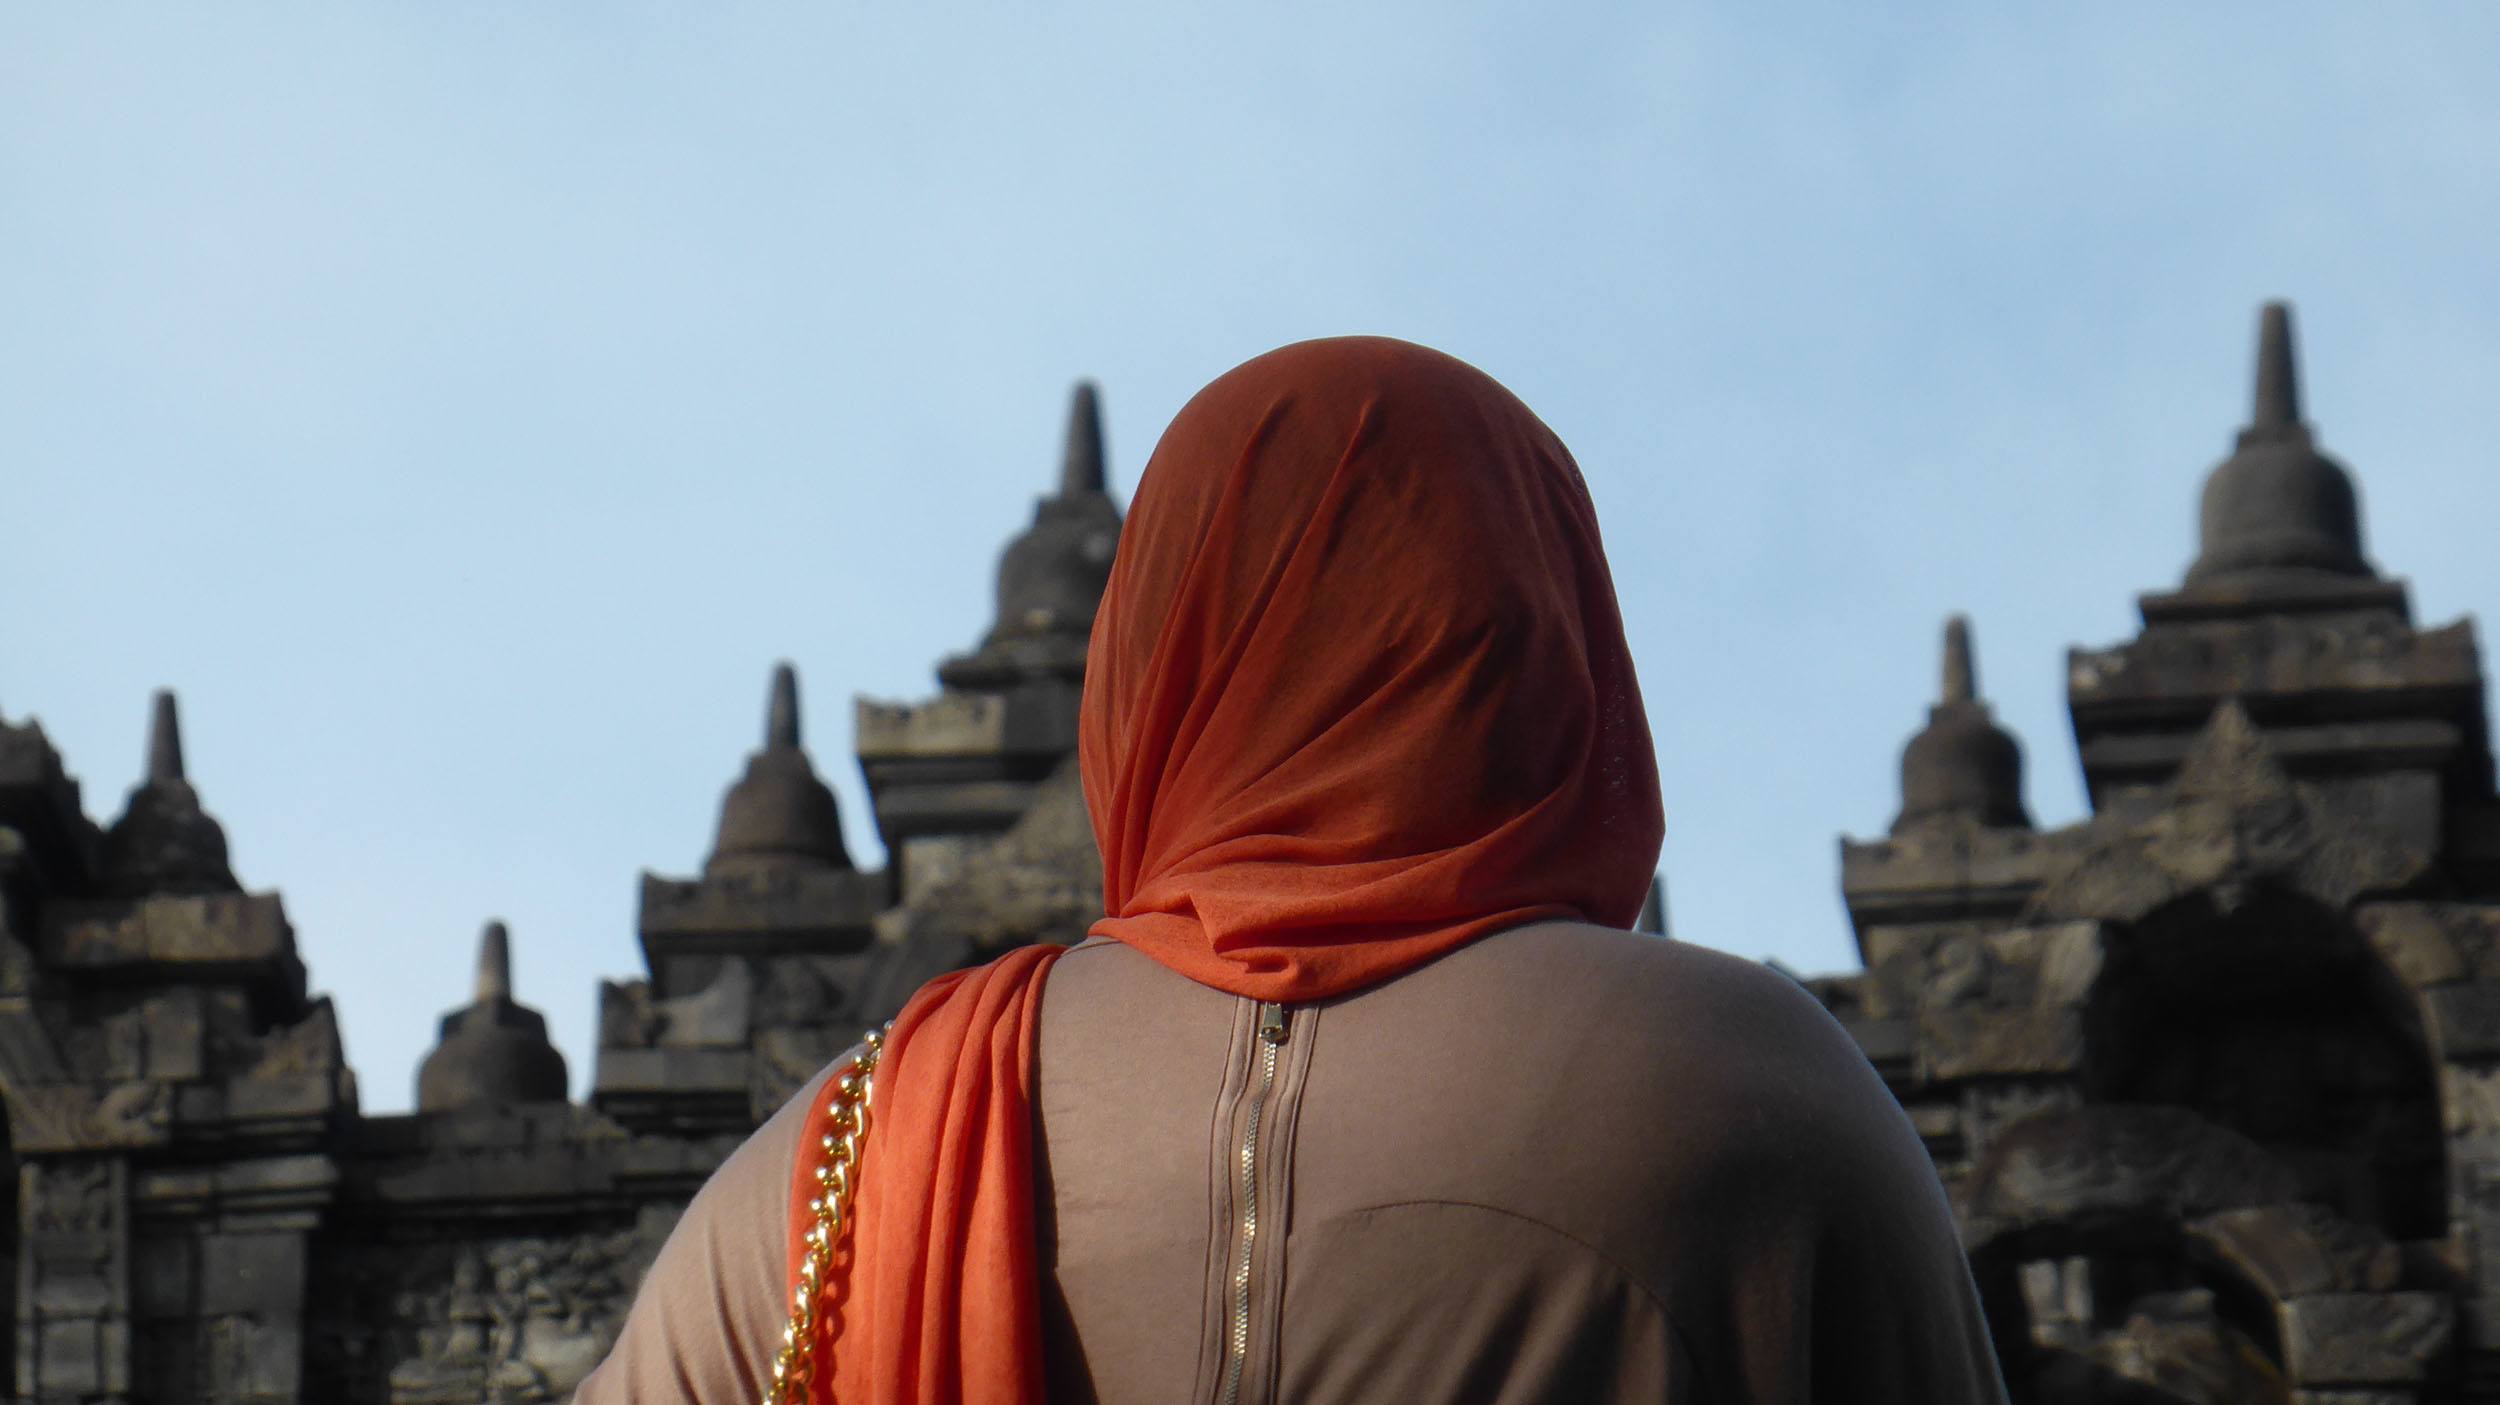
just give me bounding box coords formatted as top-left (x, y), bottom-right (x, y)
top-left (575, 923), bottom-right (2005, 1405)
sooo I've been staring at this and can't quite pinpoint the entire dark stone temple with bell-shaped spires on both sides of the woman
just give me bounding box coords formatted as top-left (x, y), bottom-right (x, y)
top-left (0, 305), bottom-right (2500, 1405)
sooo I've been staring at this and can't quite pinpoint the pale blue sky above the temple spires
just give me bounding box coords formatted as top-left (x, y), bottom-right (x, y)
top-left (0, 0), bottom-right (2500, 1110)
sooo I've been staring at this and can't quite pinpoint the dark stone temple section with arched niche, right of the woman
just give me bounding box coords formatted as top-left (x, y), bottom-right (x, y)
top-left (1810, 305), bottom-right (2500, 1405)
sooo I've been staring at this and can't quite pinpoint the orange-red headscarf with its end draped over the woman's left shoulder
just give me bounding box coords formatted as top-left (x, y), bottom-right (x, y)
top-left (793, 338), bottom-right (1663, 1405)
